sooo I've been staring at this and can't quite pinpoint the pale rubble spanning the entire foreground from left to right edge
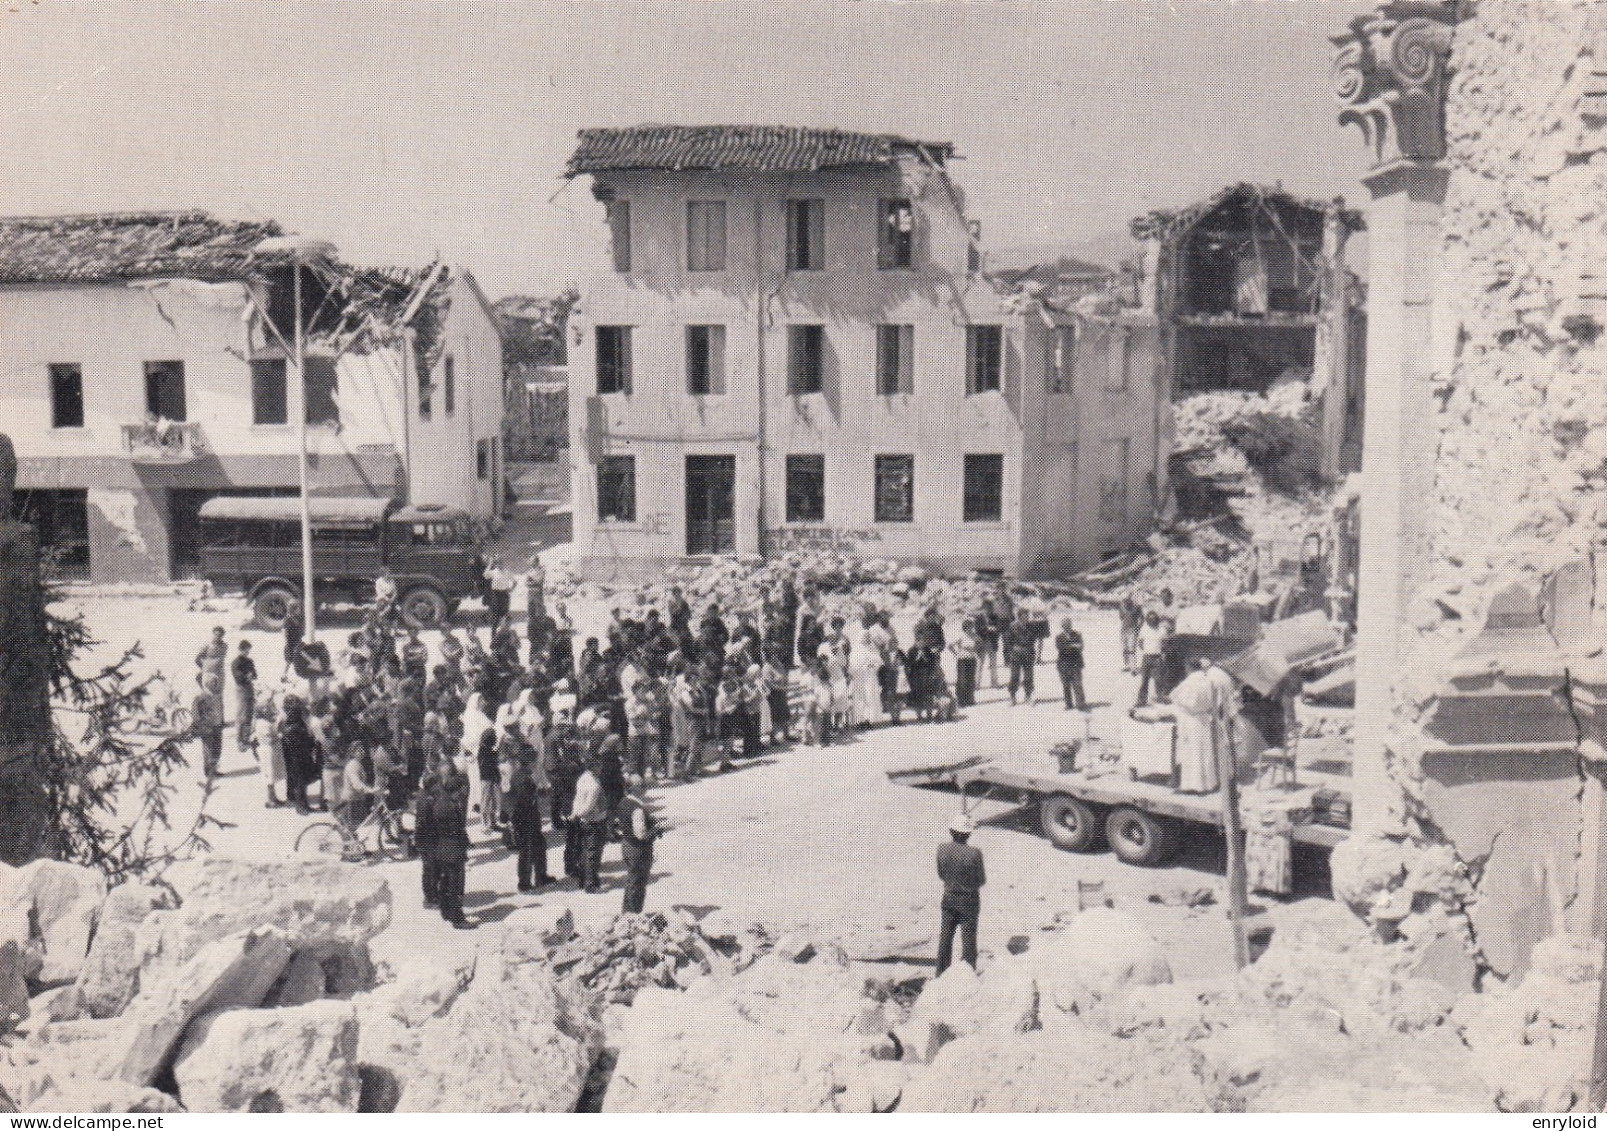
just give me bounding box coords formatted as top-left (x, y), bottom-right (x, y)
top-left (0, 859), bottom-right (1599, 1112)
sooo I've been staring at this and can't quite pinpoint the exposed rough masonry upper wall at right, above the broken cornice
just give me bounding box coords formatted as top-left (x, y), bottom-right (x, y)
top-left (1398, 0), bottom-right (1607, 707)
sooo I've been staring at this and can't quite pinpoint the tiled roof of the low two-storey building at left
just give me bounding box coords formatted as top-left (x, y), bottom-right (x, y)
top-left (0, 212), bottom-right (281, 283)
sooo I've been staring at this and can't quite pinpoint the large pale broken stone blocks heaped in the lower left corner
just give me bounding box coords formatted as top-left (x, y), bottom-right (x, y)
top-left (0, 859), bottom-right (603, 1112)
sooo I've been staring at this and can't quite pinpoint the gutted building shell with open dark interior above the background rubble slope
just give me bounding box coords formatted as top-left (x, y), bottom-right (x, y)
top-left (1130, 183), bottom-right (1366, 480)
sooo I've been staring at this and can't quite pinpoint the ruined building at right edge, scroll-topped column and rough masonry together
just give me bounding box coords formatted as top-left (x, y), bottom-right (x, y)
top-left (1334, 2), bottom-right (1607, 996)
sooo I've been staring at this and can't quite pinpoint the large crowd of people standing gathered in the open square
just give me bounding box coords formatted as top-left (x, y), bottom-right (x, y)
top-left (182, 562), bottom-right (1118, 925)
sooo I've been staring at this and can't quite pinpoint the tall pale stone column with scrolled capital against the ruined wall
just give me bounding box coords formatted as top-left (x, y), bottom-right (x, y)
top-left (1332, 0), bottom-right (1456, 834)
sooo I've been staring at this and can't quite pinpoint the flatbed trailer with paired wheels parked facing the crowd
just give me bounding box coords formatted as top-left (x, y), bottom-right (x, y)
top-left (887, 755), bottom-right (1350, 864)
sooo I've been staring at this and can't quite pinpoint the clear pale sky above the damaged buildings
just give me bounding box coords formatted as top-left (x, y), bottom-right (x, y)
top-left (0, 0), bottom-right (1372, 297)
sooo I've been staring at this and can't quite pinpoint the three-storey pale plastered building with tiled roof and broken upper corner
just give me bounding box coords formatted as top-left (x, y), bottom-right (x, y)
top-left (567, 125), bottom-right (1167, 578)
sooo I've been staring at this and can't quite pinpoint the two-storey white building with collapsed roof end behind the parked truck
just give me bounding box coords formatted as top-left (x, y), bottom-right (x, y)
top-left (0, 212), bottom-right (501, 582)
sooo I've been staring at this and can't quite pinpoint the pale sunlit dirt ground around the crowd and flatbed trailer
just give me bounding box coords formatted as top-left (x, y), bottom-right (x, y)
top-left (53, 590), bottom-right (1321, 978)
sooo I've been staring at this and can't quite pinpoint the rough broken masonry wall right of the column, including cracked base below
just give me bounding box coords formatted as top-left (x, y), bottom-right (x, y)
top-left (1335, 0), bottom-right (1607, 977)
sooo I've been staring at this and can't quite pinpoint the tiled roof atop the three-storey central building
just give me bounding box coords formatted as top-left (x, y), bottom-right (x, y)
top-left (564, 125), bottom-right (955, 177)
